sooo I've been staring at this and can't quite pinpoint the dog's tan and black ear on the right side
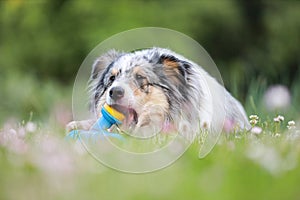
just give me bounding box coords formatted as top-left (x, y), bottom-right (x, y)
top-left (158, 54), bottom-right (190, 85)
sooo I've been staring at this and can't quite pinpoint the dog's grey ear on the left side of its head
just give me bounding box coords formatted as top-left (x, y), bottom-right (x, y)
top-left (91, 50), bottom-right (122, 80)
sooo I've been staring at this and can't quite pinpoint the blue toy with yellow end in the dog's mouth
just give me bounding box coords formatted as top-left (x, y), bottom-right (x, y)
top-left (67, 104), bottom-right (125, 140)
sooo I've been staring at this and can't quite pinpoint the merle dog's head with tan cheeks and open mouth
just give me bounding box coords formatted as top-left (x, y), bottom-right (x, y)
top-left (91, 48), bottom-right (197, 134)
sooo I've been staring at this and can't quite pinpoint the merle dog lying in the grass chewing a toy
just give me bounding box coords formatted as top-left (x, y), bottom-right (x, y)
top-left (67, 47), bottom-right (250, 137)
